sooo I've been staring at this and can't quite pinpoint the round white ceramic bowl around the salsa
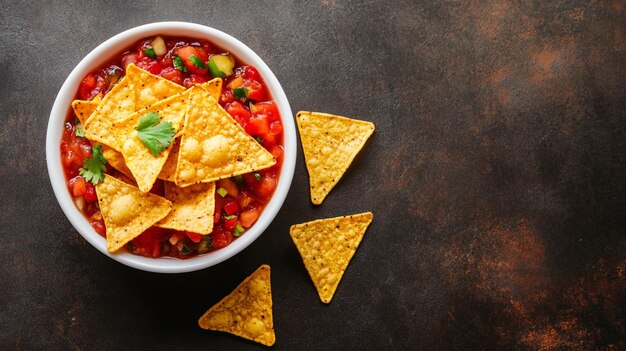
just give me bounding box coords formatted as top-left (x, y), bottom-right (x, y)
top-left (46, 22), bottom-right (296, 273)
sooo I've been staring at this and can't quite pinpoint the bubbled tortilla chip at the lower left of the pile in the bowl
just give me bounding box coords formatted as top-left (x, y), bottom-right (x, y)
top-left (96, 175), bottom-right (172, 252)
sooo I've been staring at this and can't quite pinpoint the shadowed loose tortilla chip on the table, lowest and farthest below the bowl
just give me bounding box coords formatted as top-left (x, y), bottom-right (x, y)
top-left (198, 265), bottom-right (276, 346)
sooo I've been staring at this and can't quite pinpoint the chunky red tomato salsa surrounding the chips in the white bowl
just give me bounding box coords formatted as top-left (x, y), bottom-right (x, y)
top-left (61, 36), bottom-right (283, 258)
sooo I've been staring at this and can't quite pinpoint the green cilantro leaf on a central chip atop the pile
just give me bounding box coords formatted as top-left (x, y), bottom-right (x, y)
top-left (135, 112), bottom-right (175, 157)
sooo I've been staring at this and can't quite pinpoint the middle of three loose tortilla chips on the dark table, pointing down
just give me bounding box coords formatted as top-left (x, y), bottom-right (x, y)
top-left (289, 212), bottom-right (374, 303)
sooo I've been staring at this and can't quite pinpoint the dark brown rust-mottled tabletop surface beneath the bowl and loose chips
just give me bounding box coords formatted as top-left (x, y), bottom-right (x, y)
top-left (0, 0), bottom-right (626, 350)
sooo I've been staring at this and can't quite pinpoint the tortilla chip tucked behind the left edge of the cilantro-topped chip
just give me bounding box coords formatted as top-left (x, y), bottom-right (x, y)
top-left (83, 75), bottom-right (135, 151)
